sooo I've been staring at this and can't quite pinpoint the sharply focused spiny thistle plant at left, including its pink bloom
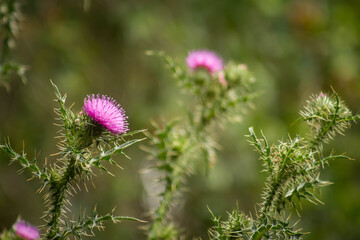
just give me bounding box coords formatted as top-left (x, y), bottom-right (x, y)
top-left (0, 83), bottom-right (143, 240)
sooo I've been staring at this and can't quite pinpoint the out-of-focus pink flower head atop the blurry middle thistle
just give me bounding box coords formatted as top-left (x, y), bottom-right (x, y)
top-left (186, 50), bottom-right (224, 74)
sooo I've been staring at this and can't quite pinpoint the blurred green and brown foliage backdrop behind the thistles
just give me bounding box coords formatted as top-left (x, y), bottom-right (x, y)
top-left (0, 0), bottom-right (360, 239)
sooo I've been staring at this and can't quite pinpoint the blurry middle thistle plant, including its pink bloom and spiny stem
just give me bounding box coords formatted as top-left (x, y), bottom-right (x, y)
top-left (148, 50), bottom-right (255, 240)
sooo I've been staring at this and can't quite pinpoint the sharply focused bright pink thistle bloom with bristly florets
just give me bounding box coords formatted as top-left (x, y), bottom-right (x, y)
top-left (83, 94), bottom-right (129, 134)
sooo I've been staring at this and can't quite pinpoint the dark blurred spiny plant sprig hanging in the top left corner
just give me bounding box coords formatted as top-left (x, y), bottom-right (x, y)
top-left (0, 0), bottom-right (27, 89)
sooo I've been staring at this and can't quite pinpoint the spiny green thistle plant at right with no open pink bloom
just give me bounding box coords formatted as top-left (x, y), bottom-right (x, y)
top-left (209, 92), bottom-right (360, 240)
